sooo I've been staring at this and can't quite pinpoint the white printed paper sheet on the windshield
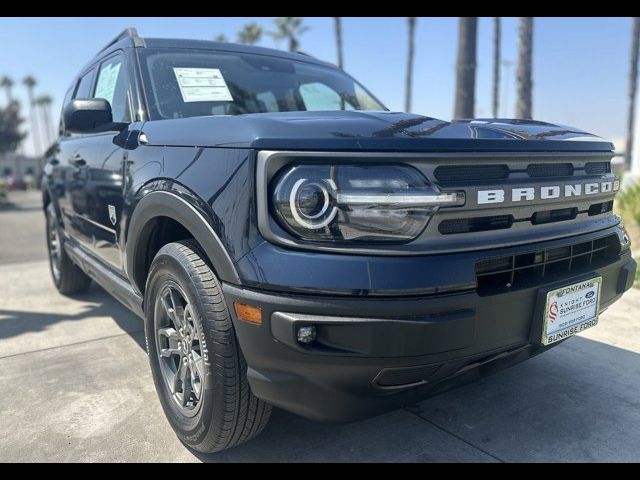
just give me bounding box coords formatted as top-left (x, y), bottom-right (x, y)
top-left (173, 67), bottom-right (233, 103)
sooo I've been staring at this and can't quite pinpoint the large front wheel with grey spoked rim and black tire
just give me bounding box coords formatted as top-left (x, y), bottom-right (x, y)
top-left (144, 241), bottom-right (271, 453)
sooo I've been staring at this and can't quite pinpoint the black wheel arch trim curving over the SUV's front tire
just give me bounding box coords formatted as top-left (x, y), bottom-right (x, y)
top-left (124, 190), bottom-right (241, 293)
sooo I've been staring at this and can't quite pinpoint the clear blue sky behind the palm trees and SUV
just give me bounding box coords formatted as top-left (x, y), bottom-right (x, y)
top-left (0, 17), bottom-right (631, 153)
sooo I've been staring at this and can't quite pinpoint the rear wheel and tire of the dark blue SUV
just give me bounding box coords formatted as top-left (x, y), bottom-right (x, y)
top-left (45, 202), bottom-right (91, 295)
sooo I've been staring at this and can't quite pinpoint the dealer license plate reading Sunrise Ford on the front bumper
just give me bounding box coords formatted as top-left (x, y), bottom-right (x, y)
top-left (542, 277), bottom-right (602, 345)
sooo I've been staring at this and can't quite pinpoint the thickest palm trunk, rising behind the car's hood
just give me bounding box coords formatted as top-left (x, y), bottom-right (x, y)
top-left (453, 17), bottom-right (478, 118)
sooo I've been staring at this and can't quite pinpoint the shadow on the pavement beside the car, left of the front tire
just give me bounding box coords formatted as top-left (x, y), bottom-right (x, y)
top-left (0, 283), bottom-right (146, 349)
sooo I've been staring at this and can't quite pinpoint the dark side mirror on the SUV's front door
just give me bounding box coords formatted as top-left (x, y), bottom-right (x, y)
top-left (63, 98), bottom-right (127, 133)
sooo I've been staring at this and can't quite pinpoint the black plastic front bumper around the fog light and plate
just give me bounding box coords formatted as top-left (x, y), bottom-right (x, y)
top-left (223, 231), bottom-right (636, 422)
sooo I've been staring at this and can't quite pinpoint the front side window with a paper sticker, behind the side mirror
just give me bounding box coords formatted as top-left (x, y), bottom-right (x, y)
top-left (93, 55), bottom-right (131, 122)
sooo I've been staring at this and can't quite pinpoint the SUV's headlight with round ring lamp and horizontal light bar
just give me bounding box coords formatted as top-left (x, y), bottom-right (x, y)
top-left (271, 165), bottom-right (464, 242)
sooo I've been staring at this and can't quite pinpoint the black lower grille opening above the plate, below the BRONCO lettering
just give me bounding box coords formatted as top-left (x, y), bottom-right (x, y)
top-left (476, 235), bottom-right (620, 295)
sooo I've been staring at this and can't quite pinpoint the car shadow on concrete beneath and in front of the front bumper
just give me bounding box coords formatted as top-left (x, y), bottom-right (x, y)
top-left (192, 337), bottom-right (640, 462)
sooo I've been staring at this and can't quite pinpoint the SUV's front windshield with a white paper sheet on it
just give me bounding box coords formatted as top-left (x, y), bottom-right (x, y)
top-left (140, 48), bottom-right (386, 119)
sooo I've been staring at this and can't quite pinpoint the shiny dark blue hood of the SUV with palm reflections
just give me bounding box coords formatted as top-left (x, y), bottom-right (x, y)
top-left (142, 111), bottom-right (613, 152)
